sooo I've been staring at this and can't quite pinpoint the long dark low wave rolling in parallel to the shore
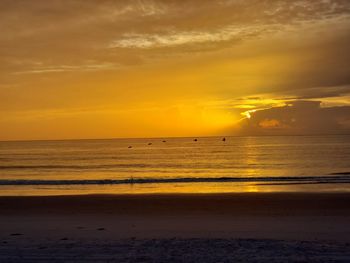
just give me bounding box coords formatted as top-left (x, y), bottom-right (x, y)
top-left (0, 175), bottom-right (350, 186)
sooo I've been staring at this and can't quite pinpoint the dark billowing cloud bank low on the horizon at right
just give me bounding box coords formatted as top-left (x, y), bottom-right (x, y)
top-left (239, 100), bottom-right (350, 135)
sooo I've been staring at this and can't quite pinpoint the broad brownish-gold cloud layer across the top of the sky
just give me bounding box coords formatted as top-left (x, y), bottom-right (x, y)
top-left (0, 0), bottom-right (350, 73)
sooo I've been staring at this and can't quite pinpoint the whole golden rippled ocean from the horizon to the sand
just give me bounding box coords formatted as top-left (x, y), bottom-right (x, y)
top-left (0, 135), bottom-right (350, 195)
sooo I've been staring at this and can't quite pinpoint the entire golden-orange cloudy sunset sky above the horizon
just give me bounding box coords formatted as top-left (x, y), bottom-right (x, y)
top-left (0, 0), bottom-right (350, 140)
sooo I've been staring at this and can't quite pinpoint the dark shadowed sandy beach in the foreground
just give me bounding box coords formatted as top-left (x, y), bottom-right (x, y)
top-left (0, 193), bottom-right (350, 262)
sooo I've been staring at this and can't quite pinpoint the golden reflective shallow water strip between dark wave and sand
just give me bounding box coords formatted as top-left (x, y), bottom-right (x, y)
top-left (0, 183), bottom-right (350, 196)
